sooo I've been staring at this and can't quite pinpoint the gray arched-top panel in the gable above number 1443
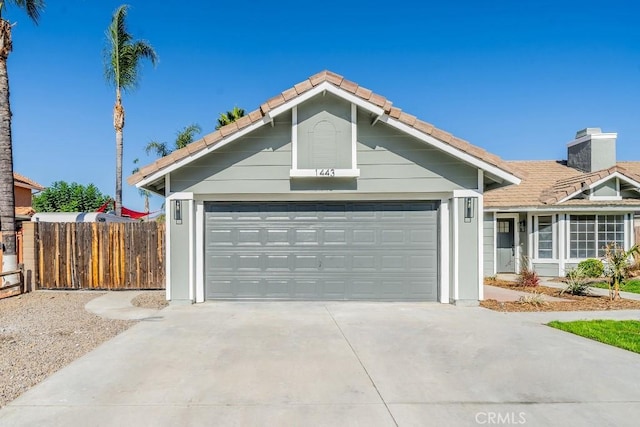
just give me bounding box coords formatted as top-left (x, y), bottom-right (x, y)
top-left (298, 94), bottom-right (351, 169)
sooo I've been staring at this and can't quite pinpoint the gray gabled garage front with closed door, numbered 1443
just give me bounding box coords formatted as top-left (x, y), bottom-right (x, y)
top-left (129, 71), bottom-right (520, 304)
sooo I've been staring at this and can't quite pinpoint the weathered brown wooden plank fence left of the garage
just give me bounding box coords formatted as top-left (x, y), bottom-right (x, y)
top-left (34, 222), bottom-right (165, 289)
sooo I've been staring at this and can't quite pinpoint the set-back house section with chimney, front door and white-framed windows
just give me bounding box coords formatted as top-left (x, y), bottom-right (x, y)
top-left (484, 128), bottom-right (640, 276)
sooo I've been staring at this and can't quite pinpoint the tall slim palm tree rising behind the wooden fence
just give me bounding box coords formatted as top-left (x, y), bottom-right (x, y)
top-left (105, 4), bottom-right (158, 216)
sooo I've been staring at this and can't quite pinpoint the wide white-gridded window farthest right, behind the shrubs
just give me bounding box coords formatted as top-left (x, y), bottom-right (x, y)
top-left (569, 215), bottom-right (624, 258)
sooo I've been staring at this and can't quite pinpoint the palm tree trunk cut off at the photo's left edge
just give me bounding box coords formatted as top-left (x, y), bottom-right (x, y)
top-left (0, 0), bottom-right (44, 284)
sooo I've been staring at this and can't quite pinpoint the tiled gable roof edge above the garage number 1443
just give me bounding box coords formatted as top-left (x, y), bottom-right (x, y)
top-left (127, 71), bottom-right (520, 185)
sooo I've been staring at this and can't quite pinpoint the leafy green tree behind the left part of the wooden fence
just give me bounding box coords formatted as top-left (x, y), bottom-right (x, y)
top-left (33, 181), bottom-right (110, 212)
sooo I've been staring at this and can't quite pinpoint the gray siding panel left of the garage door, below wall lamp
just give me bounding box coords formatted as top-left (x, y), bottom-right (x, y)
top-left (167, 200), bottom-right (191, 302)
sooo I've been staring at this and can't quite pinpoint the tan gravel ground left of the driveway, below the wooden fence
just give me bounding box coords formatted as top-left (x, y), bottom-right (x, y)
top-left (0, 291), bottom-right (135, 407)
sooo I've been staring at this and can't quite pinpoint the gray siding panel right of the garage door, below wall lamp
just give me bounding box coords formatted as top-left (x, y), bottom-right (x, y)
top-left (455, 198), bottom-right (480, 301)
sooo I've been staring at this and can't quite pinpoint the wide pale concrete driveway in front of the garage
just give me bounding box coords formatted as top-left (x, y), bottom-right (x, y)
top-left (0, 302), bottom-right (640, 426)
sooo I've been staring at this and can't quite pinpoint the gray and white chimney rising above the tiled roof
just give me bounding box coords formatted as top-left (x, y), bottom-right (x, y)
top-left (567, 128), bottom-right (618, 172)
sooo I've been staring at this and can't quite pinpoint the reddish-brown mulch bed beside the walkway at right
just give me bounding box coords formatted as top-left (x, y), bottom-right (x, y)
top-left (480, 280), bottom-right (640, 312)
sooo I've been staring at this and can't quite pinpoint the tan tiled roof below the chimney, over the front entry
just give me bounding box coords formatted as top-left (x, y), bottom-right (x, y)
top-left (484, 160), bottom-right (640, 208)
